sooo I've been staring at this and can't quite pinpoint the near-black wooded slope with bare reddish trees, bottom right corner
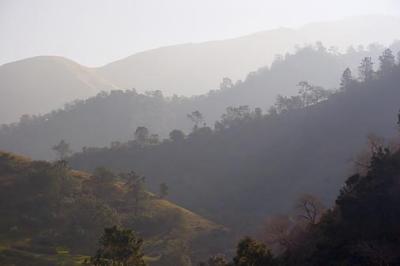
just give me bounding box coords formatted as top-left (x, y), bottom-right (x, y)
top-left (201, 138), bottom-right (400, 266)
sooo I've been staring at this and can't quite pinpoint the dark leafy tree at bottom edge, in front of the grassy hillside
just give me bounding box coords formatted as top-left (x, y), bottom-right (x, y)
top-left (88, 226), bottom-right (146, 266)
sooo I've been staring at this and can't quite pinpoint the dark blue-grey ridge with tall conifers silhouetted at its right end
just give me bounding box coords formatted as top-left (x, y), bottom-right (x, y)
top-left (69, 50), bottom-right (400, 233)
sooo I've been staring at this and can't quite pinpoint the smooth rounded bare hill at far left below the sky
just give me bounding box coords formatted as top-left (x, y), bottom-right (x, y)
top-left (0, 56), bottom-right (117, 124)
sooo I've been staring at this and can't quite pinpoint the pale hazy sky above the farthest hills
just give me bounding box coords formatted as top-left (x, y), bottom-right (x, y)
top-left (0, 0), bottom-right (400, 66)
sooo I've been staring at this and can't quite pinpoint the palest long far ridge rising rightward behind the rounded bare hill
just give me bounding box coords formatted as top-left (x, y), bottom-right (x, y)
top-left (98, 16), bottom-right (400, 96)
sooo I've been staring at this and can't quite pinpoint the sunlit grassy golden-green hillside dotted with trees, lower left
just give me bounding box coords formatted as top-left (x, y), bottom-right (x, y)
top-left (0, 152), bottom-right (228, 266)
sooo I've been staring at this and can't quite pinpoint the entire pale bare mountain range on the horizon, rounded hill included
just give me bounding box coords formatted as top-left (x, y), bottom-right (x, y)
top-left (0, 16), bottom-right (400, 123)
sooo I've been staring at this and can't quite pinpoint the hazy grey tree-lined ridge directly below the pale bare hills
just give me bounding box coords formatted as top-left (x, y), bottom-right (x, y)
top-left (0, 43), bottom-right (399, 159)
